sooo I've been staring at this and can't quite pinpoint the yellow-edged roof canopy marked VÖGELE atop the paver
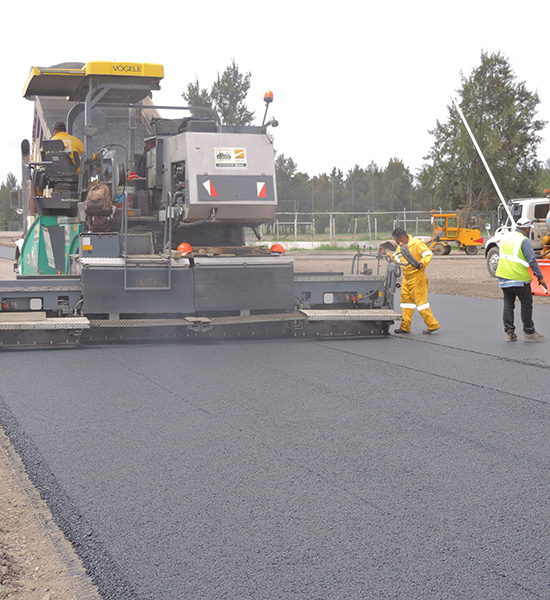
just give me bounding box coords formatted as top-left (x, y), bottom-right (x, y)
top-left (23, 61), bottom-right (164, 103)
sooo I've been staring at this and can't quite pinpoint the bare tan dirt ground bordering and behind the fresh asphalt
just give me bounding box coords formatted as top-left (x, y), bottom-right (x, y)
top-left (0, 252), bottom-right (550, 600)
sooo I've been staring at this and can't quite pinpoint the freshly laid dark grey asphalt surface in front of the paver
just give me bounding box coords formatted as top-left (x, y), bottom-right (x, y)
top-left (0, 294), bottom-right (550, 600)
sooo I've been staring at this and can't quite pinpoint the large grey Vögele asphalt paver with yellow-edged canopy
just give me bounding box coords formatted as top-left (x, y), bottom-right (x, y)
top-left (0, 62), bottom-right (400, 348)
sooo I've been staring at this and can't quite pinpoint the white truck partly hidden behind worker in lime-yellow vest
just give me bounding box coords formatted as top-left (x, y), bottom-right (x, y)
top-left (485, 198), bottom-right (550, 277)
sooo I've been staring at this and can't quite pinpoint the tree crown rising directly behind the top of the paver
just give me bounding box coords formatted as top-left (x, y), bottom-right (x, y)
top-left (182, 59), bottom-right (254, 125)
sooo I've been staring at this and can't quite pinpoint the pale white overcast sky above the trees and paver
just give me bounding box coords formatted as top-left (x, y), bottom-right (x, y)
top-left (0, 0), bottom-right (550, 181)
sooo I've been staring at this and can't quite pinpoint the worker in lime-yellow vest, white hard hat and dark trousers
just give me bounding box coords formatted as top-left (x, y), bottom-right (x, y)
top-left (496, 217), bottom-right (546, 342)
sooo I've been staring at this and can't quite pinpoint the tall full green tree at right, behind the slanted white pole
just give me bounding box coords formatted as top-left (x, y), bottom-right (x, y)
top-left (419, 52), bottom-right (545, 211)
